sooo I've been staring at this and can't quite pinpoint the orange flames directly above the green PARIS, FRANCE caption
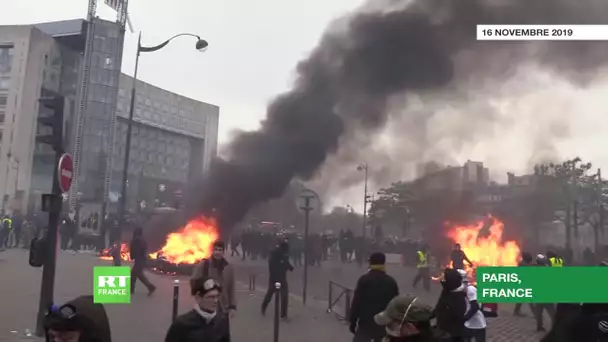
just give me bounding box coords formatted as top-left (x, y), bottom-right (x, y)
top-left (433, 216), bottom-right (520, 283)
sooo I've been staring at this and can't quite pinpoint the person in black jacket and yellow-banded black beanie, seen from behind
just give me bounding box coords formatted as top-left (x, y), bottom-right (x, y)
top-left (349, 253), bottom-right (399, 342)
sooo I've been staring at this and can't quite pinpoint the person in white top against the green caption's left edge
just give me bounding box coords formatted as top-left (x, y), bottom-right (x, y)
top-left (458, 270), bottom-right (487, 342)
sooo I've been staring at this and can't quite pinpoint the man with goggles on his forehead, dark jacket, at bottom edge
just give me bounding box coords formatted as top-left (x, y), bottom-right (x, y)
top-left (165, 277), bottom-right (230, 342)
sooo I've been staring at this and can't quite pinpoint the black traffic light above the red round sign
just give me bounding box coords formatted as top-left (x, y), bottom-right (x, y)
top-left (36, 91), bottom-right (65, 153)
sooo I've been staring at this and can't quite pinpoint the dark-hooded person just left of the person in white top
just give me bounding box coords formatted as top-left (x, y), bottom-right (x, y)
top-left (435, 268), bottom-right (467, 342)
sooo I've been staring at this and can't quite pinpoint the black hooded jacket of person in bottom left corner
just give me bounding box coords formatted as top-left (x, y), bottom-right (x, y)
top-left (44, 296), bottom-right (112, 342)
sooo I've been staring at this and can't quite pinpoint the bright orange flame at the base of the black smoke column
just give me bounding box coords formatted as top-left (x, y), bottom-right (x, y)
top-left (150, 216), bottom-right (219, 264)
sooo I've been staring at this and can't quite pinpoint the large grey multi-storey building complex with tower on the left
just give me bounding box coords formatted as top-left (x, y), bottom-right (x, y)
top-left (0, 18), bottom-right (219, 217)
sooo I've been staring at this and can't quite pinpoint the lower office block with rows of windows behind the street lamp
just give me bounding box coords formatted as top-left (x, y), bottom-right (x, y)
top-left (110, 74), bottom-right (219, 210)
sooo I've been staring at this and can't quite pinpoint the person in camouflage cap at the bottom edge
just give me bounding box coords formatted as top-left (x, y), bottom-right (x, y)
top-left (374, 295), bottom-right (439, 342)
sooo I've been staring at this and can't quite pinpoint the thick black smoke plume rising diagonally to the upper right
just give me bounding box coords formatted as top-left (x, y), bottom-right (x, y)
top-left (189, 0), bottom-right (608, 232)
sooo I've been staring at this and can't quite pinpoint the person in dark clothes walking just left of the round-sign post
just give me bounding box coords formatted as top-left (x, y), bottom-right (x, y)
top-left (262, 240), bottom-right (293, 319)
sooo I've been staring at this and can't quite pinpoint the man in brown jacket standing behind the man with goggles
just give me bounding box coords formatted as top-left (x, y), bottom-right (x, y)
top-left (192, 240), bottom-right (236, 318)
